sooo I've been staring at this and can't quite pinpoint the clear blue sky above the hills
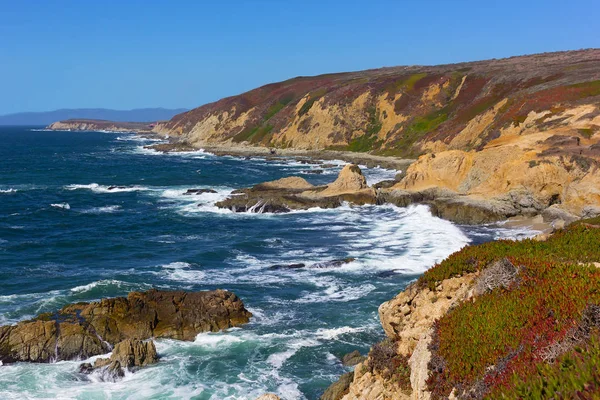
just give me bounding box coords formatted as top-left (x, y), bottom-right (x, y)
top-left (0, 0), bottom-right (600, 114)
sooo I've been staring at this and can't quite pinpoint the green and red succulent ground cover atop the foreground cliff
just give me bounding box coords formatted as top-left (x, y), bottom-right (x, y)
top-left (418, 222), bottom-right (600, 399)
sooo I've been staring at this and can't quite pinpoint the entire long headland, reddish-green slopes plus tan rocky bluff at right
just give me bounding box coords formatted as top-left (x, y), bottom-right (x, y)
top-left (155, 49), bottom-right (600, 219)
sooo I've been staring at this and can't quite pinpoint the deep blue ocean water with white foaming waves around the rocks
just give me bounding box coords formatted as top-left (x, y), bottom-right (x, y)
top-left (0, 127), bottom-right (533, 399)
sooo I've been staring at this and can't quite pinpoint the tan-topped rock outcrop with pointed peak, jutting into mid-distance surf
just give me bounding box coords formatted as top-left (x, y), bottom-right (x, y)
top-left (216, 164), bottom-right (377, 213)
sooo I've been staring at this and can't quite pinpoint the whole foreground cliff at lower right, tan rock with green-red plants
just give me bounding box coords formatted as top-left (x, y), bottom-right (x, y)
top-left (327, 218), bottom-right (600, 400)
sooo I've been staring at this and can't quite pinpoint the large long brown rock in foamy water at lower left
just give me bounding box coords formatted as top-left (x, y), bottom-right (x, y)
top-left (0, 290), bottom-right (252, 363)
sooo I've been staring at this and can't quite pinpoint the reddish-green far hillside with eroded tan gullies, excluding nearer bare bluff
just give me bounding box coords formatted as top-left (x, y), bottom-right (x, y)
top-left (156, 50), bottom-right (600, 157)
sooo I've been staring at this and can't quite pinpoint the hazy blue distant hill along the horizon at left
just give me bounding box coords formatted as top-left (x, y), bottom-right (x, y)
top-left (0, 108), bottom-right (187, 125)
